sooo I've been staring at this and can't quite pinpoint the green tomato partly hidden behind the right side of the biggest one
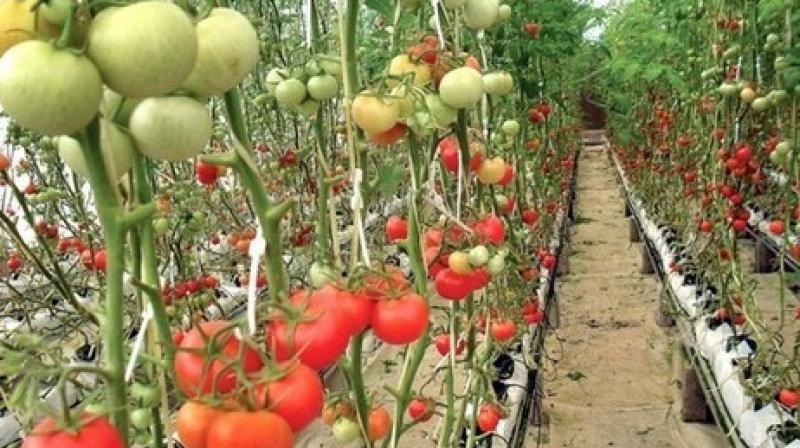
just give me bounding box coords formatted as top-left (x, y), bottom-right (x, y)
top-left (184, 8), bottom-right (259, 96)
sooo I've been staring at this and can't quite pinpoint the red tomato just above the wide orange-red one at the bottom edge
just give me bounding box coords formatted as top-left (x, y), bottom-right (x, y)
top-left (255, 362), bottom-right (325, 432)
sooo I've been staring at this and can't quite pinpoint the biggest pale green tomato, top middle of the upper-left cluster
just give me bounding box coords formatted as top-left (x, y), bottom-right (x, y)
top-left (87, 1), bottom-right (198, 98)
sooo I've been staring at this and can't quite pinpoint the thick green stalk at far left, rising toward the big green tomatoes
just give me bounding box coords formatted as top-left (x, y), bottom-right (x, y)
top-left (81, 120), bottom-right (128, 447)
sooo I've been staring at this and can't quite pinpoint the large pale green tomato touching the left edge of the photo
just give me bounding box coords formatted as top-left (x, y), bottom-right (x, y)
top-left (0, 40), bottom-right (103, 135)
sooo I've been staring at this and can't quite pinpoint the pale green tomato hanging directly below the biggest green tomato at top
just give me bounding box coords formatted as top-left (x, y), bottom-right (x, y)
top-left (130, 96), bottom-right (213, 162)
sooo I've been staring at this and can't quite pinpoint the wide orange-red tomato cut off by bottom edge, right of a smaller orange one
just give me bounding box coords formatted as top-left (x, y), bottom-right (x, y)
top-left (206, 411), bottom-right (294, 448)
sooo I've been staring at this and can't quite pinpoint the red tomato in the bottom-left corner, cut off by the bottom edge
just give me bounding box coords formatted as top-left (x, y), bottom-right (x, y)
top-left (22, 414), bottom-right (125, 448)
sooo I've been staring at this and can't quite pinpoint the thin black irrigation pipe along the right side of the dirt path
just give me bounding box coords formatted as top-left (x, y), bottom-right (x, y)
top-left (608, 152), bottom-right (747, 448)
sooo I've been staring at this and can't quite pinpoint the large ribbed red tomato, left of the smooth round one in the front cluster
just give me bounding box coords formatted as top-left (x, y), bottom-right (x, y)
top-left (267, 291), bottom-right (352, 371)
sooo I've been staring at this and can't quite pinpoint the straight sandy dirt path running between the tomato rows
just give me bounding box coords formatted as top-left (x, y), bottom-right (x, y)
top-left (542, 151), bottom-right (728, 448)
